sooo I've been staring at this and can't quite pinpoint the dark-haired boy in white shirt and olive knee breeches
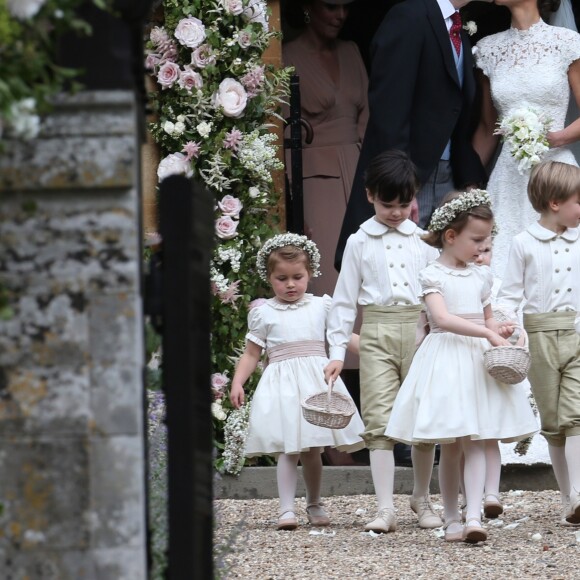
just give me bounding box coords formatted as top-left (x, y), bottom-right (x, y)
top-left (325, 150), bottom-right (443, 532)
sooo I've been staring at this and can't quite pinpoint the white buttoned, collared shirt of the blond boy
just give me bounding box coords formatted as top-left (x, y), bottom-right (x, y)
top-left (498, 222), bottom-right (580, 314)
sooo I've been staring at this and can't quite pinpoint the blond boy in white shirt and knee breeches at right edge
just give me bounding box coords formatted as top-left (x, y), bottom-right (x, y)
top-left (498, 161), bottom-right (580, 524)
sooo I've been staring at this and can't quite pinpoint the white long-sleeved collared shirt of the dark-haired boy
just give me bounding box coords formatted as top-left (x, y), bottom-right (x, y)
top-left (327, 217), bottom-right (439, 360)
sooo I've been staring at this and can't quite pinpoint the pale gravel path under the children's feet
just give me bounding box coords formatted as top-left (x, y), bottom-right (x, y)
top-left (215, 491), bottom-right (580, 580)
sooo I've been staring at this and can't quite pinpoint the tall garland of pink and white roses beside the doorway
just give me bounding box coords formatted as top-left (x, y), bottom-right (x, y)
top-left (146, 0), bottom-right (290, 470)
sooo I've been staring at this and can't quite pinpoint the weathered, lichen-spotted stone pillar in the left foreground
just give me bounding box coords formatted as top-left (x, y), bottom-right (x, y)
top-left (0, 91), bottom-right (146, 580)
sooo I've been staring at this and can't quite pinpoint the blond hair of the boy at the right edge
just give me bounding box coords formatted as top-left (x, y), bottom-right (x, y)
top-left (528, 161), bottom-right (580, 213)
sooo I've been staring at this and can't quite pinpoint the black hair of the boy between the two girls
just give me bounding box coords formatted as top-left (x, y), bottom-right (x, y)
top-left (365, 149), bottom-right (419, 203)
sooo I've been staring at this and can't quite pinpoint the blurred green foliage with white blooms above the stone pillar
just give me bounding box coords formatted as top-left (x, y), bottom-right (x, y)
top-left (0, 0), bottom-right (110, 140)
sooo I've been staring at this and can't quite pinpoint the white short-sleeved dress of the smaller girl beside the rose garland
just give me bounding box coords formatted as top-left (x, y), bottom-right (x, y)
top-left (245, 294), bottom-right (364, 457)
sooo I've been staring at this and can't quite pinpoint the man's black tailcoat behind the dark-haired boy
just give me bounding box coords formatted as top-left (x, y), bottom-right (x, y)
top-left (335, 0), bottom-right (487, 269)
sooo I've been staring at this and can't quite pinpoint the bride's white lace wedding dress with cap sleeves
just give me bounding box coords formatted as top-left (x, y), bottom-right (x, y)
top-left (475, 20), bottom-right (580, 277)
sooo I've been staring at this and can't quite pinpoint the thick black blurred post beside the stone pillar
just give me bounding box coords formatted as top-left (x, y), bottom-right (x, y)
top-left (159, 176), bottom-right (214, 580)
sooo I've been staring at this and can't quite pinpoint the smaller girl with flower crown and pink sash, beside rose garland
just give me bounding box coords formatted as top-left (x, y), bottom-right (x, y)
top-left (230, 233), bottom-right (364, 530)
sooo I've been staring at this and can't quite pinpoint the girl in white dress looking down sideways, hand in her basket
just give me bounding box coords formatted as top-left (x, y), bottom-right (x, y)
top-left (385, 190), bottom-right (537, 542)
